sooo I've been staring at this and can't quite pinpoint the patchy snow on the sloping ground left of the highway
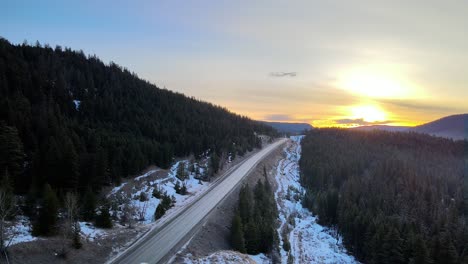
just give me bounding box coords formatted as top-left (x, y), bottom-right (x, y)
top-left (6, 157), bottom-right (210, 250)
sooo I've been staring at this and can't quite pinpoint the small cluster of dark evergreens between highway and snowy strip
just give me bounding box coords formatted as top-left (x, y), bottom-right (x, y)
top-left (231, 172), bottom-right (278, 255)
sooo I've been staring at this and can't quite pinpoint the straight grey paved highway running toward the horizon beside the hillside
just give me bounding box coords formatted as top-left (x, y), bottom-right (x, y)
top-left (110, 139), bottom-right (287, 264)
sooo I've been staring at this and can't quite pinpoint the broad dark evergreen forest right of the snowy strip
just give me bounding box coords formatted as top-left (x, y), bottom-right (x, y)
top-left (300, 129), bottom-right (468, 264)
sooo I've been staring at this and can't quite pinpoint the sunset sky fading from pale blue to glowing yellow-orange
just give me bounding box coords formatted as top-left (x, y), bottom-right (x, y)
top-left (0, 0), bottom-right (468, 127)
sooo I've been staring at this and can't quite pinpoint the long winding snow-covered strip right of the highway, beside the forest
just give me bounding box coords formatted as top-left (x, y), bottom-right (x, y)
top-left (275, 136), bottom-right (358, 263)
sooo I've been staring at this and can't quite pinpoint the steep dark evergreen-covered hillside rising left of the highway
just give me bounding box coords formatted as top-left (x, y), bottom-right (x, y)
top-left (0, 39), bottom-right (274, 196)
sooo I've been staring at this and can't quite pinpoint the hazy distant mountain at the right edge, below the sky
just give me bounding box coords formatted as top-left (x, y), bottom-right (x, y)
top-left (411, 114), bottom-right (468, 139)
